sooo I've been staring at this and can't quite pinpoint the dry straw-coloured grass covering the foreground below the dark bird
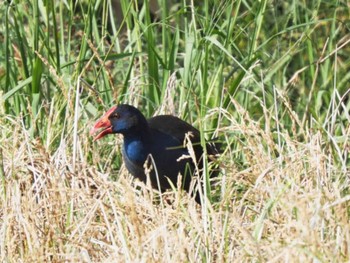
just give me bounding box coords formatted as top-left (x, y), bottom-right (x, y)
top-left (0, 98), bottom-right (350, 262)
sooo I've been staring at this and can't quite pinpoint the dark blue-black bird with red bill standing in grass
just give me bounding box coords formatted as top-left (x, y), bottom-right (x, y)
top-left (90, 104), bottom-right (219, 204)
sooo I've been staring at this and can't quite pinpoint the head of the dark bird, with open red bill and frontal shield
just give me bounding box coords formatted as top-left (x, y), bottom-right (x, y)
top-left (90, 104), bottom-right (147, 141)
